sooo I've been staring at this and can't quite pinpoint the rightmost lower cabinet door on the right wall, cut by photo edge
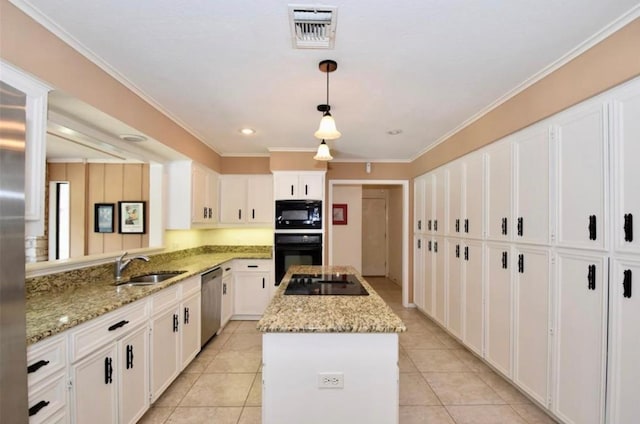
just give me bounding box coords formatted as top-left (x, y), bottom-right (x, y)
top-left (607, 260), bottom-right (640, 423)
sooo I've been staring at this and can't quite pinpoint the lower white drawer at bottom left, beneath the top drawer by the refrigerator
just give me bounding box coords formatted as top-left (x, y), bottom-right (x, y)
top-left (29, 372), bottom-right (67, 424)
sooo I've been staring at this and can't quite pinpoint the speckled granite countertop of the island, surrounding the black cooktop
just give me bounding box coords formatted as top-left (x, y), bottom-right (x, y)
top-left (257, 265), bottom-right (406, 333)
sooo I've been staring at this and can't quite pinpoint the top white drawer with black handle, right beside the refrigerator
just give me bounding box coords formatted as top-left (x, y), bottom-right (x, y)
top-left (27, 335), bottom-right (67, 387)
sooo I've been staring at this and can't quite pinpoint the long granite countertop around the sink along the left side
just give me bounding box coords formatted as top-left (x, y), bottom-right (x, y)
top-left (26, 246), bottom-right (272, 345)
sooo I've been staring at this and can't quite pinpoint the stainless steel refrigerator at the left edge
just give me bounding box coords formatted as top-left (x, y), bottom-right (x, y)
top-left (0, 81), bottom-right (28, 424)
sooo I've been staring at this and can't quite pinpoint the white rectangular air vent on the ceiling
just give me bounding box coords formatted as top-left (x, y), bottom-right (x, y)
top-left (289, 5), bottom-right (338, 49)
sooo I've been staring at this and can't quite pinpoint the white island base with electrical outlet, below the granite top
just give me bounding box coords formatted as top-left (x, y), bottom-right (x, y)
top-left (262, 333), bottom-right (399, 424)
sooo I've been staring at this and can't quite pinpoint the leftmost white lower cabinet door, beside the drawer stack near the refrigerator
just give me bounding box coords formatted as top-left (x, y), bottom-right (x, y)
top-left (71, 343), bottom-right (118, 424)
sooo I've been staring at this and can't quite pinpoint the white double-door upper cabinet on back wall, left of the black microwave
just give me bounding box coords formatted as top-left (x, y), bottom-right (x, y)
top-left (220, 175), bottom-right (273, 225)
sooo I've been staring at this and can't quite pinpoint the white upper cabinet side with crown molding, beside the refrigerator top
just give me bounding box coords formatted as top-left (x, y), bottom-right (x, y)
top-left (0, 62), bottom-right (50, 237)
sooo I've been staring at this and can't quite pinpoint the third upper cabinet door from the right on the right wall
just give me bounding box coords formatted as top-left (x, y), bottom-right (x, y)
top-left (511, 123), bottom-right (550, 244)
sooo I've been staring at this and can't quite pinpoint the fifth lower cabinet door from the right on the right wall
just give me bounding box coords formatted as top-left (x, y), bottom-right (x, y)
top-left (460, 240), bottom-right (484, 356)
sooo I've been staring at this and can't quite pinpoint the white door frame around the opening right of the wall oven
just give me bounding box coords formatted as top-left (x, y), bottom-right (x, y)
top-left (325, 180), bottom-right (411, 307)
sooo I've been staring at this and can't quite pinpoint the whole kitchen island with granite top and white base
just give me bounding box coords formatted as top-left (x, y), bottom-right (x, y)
top-left (258, 265), bottom-right (406, 424)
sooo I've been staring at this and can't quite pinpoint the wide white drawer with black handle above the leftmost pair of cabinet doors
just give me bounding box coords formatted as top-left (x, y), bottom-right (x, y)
top-left (71, 299), bottom-right (149, 362)
